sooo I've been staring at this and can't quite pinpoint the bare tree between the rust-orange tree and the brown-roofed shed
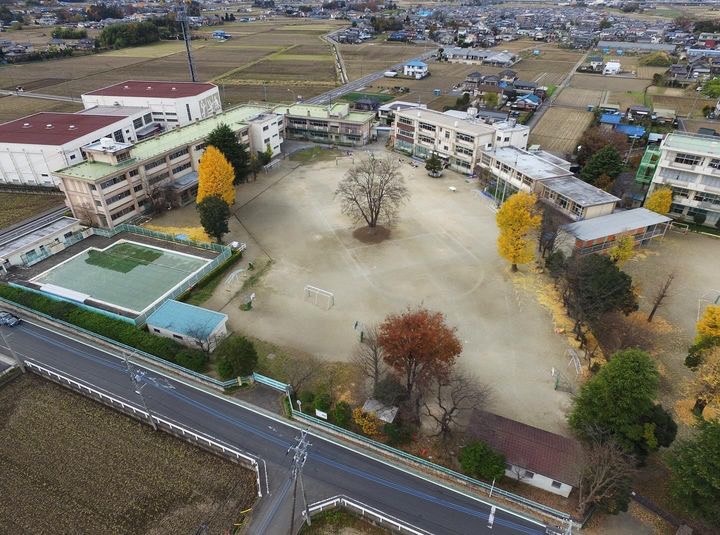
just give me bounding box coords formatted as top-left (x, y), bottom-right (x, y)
top-left (424, 370), bottom-right (491, 440)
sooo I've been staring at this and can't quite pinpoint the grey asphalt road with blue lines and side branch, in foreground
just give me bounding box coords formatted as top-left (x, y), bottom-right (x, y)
top-left (0, 321), bottom-right (545, 535)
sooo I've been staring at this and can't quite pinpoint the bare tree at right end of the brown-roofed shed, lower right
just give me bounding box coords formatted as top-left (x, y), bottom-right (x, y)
top-left (578, 436), bottom-right (635, 513)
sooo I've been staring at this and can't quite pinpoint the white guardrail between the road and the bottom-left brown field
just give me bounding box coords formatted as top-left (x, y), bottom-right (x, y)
top-left (25, 360), bottom-right (270, 498)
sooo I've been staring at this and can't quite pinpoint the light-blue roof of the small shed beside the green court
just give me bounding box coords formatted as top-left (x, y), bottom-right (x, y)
top-left (147, 299), bottom-right (227, 339)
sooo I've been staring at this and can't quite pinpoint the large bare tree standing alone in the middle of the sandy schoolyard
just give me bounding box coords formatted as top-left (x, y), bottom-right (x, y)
top-left (335, 155), bottom-right (410, 229)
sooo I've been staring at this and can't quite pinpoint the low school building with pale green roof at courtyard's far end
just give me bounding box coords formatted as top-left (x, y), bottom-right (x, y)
top-left (273, 104), bottom-right (375, 146)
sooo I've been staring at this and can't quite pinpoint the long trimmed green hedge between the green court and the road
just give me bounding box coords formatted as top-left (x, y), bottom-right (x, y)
top-left (0, 284), bottom-right (208, 372)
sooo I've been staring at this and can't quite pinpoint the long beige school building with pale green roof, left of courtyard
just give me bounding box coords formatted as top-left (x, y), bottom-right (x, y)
top-left (54, 106), bottom-right (283, 227)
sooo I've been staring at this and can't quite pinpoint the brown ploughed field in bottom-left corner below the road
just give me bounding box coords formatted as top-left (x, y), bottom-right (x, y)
top-left (0, 374), bottom-right (256, 533)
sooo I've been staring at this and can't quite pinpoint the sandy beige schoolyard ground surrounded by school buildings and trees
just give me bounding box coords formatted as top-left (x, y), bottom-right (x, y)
top-left (154, 149), bottom-right (575, 433)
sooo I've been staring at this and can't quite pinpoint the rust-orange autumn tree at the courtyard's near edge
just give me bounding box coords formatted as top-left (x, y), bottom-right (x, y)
top-left (378, 308), bottom-right (462, 421)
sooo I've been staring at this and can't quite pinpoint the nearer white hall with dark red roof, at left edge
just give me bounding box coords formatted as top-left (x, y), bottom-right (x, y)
top-left (0, 112), bottom-right (143, 187)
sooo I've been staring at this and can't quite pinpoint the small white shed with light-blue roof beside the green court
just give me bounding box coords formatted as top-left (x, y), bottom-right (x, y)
top-left (147, 299), bottom-right (228, 351)
